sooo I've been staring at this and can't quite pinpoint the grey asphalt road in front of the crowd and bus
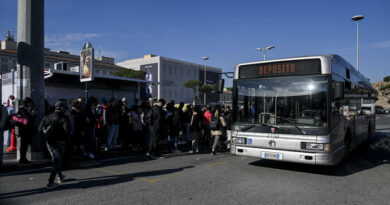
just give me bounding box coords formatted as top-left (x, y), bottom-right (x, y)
top-left (0, 115), bottom-right (390, 205)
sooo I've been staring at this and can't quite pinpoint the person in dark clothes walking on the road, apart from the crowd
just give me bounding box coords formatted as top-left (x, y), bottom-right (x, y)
top-left (39, 101), bottom-right (70, 189)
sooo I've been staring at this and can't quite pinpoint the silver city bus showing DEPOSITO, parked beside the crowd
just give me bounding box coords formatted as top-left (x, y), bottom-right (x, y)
top-left (227, 54), bottom-right (376, 166)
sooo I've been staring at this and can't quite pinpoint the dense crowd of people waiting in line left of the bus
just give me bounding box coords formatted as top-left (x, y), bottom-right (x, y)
top-left (3, 96), bottom-right (231, 165)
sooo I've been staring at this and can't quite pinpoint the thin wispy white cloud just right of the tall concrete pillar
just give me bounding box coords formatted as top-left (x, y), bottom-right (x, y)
top-left (45, 33), bottom-right (102, 51)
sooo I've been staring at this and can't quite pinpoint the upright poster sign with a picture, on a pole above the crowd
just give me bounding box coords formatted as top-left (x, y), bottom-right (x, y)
top-left (79, 47), bottom-right (95, 82)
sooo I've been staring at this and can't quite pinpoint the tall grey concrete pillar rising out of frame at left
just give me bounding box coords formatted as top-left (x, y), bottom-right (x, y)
top-left (17, 0), bottom-right (45, 160)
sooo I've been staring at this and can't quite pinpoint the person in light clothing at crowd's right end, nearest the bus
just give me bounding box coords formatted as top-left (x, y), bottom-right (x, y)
top-left (210, 108), bottom-right (226, 155)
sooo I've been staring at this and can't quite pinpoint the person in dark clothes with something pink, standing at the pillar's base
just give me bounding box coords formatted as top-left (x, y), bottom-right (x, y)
top-left (17, 97), bottom-right (37, 165)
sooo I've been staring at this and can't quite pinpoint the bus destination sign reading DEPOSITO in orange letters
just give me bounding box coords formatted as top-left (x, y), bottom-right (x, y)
top-left (239, 59), bottom-right (321, 79)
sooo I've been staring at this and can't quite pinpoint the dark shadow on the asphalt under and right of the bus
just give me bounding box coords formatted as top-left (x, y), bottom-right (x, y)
top-left (250, 130), bottom-right (390, 177)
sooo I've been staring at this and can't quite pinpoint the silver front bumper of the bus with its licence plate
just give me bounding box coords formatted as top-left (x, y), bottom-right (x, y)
top-left (230, 145), bottom-right (337, 165)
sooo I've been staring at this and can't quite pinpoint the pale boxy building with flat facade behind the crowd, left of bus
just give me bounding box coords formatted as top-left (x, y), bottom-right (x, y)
top-left (117, 54), bottom-right (222, 104)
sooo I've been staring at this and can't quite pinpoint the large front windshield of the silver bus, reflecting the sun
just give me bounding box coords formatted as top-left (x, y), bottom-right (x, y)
top-left (233, 76), bottom-right (328, 133)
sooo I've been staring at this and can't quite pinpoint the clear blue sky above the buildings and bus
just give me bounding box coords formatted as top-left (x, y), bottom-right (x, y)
top-left (0, 0), bottom-right (390, 86)
